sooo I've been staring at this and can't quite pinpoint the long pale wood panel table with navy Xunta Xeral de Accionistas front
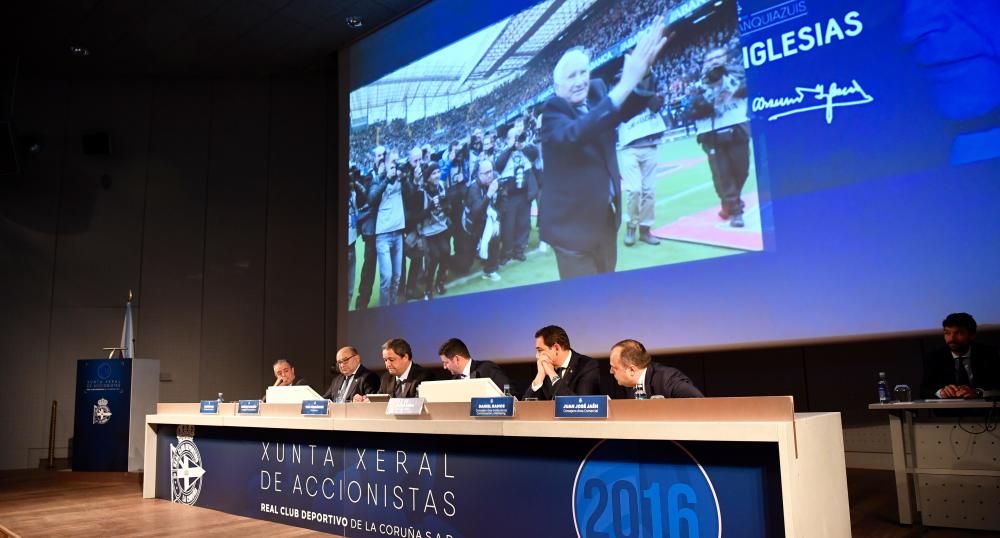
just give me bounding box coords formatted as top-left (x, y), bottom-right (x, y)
top-left (143, 397), bottom-right (851, 538)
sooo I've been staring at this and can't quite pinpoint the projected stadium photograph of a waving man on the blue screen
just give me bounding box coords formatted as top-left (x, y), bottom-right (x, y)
top-left (346, 0), bottom-right (764, 310)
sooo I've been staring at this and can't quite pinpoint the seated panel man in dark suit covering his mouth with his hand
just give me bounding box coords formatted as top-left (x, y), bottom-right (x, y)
top-left (524, 325), bottom-right (601, 400)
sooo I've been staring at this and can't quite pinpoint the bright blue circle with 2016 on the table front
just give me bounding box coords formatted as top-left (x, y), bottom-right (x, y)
top-left (573, 440), bottom-right (722, 538)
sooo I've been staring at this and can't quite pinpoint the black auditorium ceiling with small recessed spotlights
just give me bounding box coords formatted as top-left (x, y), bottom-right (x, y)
top-left (7, 0), bottom-right (426, 76)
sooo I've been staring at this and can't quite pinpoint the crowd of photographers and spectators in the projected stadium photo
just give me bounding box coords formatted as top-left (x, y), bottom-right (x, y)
top-left (347, 0), bottom-right (746, 309)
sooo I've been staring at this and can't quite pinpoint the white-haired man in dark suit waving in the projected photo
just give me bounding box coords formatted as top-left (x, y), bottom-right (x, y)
top-left (539, 18), bottom-right (666, 278)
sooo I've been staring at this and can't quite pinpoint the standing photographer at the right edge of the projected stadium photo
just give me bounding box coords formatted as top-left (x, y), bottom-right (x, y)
top-left (691, 47), bottom-right (750, 228)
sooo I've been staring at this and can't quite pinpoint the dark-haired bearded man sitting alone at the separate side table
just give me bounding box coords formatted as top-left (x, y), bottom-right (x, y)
top-left (920, 312), bottom-right (1000, 398)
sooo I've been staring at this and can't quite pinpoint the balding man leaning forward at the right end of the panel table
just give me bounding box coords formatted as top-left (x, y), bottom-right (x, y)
top-left (610, 340), bottom-right (704, 398)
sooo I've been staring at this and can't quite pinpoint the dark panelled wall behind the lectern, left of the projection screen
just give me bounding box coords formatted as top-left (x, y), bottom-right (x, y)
top-left (0, 74), bottom-right (338, 468)
